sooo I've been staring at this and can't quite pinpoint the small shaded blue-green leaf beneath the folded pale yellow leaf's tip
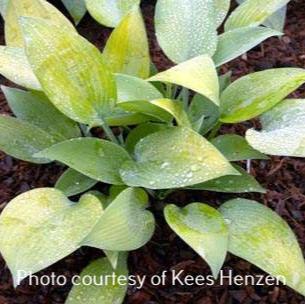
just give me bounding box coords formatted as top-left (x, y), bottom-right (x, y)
top-left (188, 94), bottom-right (220, 135)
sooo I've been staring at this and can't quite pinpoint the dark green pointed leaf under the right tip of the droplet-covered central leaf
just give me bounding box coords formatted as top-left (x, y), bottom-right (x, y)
top-left (189, 165), bottom-right (266, 193)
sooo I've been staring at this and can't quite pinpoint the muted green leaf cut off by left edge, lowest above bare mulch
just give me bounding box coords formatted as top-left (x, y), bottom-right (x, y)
top-left (0, 115), bottom-right (56, 163)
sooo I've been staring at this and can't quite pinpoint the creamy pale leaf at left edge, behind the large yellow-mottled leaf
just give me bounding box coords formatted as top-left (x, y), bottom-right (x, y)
top-left (0, 46), bottom-right (41, 90)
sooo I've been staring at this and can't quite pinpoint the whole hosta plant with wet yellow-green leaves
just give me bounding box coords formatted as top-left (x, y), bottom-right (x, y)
top-left (0, 0), bottom-right (305, 303)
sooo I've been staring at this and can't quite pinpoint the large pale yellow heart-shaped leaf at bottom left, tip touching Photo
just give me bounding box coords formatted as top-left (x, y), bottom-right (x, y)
top-left (0, 188), bottom-right (101, 286)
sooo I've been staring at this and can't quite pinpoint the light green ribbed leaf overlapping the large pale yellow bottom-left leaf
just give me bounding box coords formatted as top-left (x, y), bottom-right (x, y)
top-left (82, 188), bottom-right (155, 251)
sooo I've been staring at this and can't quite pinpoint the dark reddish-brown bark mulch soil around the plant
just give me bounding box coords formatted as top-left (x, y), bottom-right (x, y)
top-left (0, 0), bottom-right (305, 304)
